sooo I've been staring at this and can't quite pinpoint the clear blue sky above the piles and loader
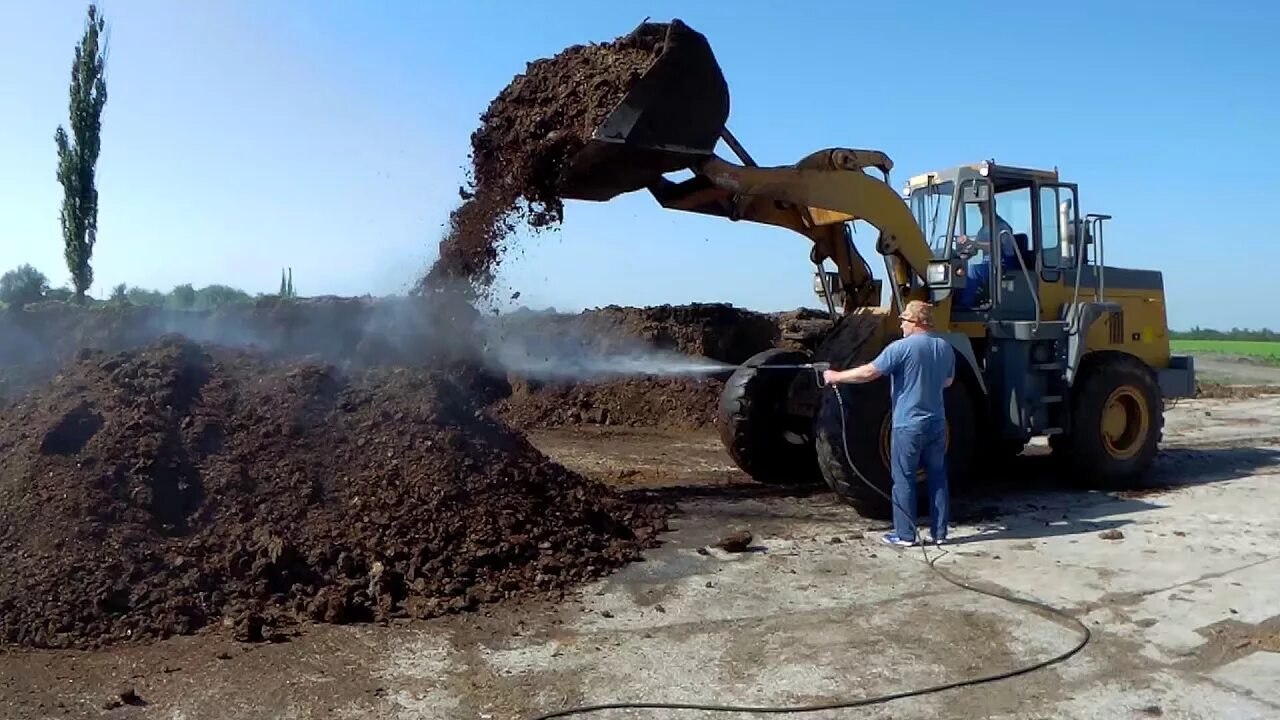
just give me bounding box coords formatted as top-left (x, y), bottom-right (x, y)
top-left (0, 0), bottom-right (1280, 328)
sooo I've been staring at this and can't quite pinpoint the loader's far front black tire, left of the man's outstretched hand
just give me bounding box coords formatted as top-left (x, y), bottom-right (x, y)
top-left (718, 347), bottom-right (820, 486)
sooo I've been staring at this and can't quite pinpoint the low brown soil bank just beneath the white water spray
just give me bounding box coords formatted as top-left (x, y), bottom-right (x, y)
top-left (494, 378), bottom-right (724, 429)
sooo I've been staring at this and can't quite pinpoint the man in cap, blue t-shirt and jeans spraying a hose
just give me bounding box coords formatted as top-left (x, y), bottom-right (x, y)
top-left (823, 300), bottom-right (956, 546)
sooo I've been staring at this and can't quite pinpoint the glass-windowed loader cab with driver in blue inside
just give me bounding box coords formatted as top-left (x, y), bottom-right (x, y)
top-left (904, 161), bottom-right (1080, 322)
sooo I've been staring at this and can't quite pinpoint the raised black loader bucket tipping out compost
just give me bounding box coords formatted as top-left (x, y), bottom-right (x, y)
top-left (561, 19), bottom-right (728, 200)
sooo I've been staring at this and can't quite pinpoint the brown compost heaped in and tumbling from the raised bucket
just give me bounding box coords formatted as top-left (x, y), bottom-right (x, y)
top-left (419, 23), bottom-right (667, 293)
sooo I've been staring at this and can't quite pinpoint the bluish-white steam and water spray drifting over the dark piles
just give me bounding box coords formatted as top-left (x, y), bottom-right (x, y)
top-left (0, 295), bottom-right (737, 409)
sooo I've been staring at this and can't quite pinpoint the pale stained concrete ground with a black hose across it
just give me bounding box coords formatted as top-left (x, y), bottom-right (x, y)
top-left (0, 397), bottom-right (1280, 720)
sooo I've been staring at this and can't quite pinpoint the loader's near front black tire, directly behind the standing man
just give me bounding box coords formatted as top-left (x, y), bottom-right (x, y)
top-left (814, 368), bottom-right (977, 520)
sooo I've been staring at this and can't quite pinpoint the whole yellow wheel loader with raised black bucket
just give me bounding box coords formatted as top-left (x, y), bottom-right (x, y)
top-left (562, 19), bottom-right (1196, 518)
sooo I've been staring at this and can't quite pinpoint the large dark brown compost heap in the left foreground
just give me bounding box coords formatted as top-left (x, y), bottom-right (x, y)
top-left (0, 338), bottom-right (666, 647)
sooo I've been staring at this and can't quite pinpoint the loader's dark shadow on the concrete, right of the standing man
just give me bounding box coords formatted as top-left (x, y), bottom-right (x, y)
top-left (942, 447), bottom-right (1280, 544)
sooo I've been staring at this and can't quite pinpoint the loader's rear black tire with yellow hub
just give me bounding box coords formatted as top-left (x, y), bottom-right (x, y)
top-left (1050, 352), bottom-right (1164, 487)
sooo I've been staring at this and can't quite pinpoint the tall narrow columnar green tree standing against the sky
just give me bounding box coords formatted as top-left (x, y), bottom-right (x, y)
top-left (54, 4), bottom-right (106, 302)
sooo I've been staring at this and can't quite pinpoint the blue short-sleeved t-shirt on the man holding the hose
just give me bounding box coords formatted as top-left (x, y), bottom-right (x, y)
top-left (872, 333), bottom-right (956, 428)
